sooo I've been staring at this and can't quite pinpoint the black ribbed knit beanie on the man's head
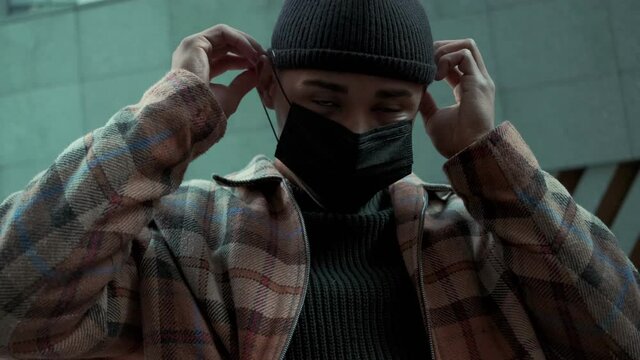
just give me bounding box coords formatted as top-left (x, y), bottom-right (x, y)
top-left (271, 0), bottom-right (436, 84)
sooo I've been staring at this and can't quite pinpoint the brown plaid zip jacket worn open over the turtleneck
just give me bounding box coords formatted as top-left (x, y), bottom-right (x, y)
top-left (0, 71), bottom-right (640, 359)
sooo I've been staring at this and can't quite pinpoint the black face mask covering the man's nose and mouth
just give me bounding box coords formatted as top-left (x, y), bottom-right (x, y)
top-left (275, 103), bottom-right (413, 211)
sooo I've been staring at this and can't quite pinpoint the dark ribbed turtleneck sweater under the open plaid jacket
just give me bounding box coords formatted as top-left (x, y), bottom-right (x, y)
top-left (286, 187), bottom-right (430, 360)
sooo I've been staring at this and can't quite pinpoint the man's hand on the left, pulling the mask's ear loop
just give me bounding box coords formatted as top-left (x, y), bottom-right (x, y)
top-left (171, 25), bottom-right (265, 117)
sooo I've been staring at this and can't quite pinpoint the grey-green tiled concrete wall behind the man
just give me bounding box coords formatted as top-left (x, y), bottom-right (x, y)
top-left (0, 0), bottom-right (640, 248)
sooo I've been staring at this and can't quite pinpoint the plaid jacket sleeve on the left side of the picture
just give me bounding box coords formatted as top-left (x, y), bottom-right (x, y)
top-left (0, 70), bottom-right (227, 358)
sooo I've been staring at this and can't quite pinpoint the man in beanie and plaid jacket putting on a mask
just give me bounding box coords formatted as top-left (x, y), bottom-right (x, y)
top-left (0, 0), bottom-right (640, 359)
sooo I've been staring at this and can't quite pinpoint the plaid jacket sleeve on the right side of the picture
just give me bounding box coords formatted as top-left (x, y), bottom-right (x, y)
top-left (444, 122), bottom-right (640, 359)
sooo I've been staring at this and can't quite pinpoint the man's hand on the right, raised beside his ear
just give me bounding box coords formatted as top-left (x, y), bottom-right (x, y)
top-left (420, 39), bottom-right (495, 158)
